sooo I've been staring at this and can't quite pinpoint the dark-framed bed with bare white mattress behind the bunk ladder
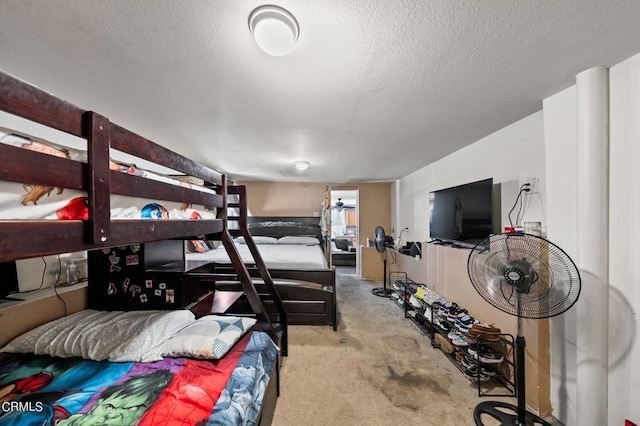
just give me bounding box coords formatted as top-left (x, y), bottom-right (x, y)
top-left (186, 199), bottom-right (338, 331)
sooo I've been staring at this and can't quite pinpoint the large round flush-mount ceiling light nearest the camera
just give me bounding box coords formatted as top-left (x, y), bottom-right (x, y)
top-left (249, 5), bottom-right (300, 56)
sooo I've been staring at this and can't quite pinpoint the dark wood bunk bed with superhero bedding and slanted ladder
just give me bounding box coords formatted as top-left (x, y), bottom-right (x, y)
top-left (0, 72), bottom-right (287, 424)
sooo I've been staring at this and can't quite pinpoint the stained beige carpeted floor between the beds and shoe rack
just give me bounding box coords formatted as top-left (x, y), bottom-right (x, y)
top-left (273, 268), bottom-right (514, 426)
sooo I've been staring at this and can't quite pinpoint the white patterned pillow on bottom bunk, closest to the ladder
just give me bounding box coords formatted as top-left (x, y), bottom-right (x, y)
top-left (161, 315), bottom-right (256, 359)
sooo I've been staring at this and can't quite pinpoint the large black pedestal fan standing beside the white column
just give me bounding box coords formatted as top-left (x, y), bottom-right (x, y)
top-left (467, 233), bottom-right (581, 426)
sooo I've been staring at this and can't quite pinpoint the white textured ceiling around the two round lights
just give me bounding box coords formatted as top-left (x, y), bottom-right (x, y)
top-left (0, 0), bottom-right (640, 183)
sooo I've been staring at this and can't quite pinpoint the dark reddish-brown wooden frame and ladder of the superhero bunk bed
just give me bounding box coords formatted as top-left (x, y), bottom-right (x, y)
top-left (0, 71), bottom-right (287, 424)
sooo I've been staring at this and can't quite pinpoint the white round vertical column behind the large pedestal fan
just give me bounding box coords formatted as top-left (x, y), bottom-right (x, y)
top-left (576, 67), bottom-right (609, 425)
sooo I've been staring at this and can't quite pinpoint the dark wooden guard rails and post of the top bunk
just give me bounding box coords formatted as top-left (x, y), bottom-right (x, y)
top-left (0, 72), bottom-right (226, 261)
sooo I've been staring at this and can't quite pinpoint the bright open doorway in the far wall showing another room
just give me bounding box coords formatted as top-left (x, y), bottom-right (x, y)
top-left (331, 189), bottom-right (359, 273)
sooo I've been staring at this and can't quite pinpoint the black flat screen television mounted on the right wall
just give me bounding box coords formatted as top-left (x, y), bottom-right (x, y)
top-left (429, 178), bottom-right (500, 247)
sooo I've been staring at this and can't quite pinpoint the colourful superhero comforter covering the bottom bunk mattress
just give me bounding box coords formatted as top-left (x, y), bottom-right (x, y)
top-left (0, 331), bottom-right (277, 426)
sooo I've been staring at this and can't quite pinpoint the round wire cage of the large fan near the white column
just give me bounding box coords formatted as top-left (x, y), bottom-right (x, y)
top-left (467, 233), bottom-right (580, 319)
